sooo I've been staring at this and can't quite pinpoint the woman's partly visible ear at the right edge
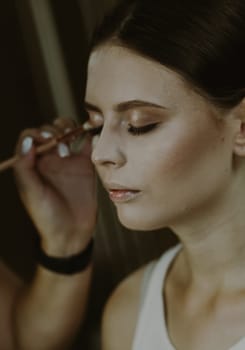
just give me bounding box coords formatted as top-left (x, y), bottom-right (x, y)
top-left (232, 98), bottom-right (245, 157)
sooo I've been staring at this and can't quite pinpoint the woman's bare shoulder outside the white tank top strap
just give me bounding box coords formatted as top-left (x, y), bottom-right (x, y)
top-left (102, 265), bottom-right (151, 350)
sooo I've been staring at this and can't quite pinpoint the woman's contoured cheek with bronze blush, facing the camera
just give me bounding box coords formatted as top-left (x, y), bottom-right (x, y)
top-left (136, 119), bottom-right (230, 204)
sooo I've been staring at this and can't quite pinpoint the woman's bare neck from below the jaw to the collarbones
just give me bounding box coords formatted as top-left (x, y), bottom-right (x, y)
top-left (171, 178), bottom-right (245, 293)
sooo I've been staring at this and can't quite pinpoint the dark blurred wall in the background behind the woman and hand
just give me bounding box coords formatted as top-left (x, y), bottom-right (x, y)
top-left (0, 0), bottom-right (176, 350)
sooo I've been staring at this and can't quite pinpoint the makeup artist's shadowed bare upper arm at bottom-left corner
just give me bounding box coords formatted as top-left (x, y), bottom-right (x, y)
top-left (0, 261), bottom-right (23, 350)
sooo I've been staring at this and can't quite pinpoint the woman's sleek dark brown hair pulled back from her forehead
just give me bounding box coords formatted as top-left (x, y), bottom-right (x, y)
top-left (91, 0), bottom-right (245, 108)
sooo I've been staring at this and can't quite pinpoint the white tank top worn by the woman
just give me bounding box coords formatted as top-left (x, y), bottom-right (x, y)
top-left (132, 244), bottom-right (245, 350)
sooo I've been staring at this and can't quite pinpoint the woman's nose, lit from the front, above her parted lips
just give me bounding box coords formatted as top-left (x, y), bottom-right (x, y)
top-left (91, 128), bottom-right (126, 168)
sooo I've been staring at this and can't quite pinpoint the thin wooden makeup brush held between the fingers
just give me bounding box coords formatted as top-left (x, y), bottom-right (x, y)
top-left (0, 123), bottom-right (96, 172)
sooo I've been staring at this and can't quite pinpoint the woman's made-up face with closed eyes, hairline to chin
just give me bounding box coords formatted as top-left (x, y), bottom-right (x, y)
top-left (85, 46), bottom-right (232, 230)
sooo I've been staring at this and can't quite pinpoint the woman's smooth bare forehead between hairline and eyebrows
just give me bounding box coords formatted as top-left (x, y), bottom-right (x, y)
top-left (86, 45), bottom-right (189, 105)
